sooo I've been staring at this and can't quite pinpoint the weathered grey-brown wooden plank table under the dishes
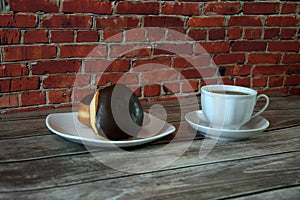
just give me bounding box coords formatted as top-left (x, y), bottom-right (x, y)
top-left (0, 95), bottom-right (300, 199)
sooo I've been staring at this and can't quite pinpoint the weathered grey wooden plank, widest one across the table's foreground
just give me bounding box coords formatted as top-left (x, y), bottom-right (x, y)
top-left (0, 152), bottom-right (300, 199)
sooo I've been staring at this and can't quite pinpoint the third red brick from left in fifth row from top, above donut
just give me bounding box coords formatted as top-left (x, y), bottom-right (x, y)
top-left (84, 60), bottom-right (130, 73)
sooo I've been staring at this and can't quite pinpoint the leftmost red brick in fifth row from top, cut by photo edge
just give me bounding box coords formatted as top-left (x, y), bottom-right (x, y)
top-left (0, 64), bottom-right (28, 77)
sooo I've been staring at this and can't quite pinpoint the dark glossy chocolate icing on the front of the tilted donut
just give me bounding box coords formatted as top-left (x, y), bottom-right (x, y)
top-left (96, 84), bottom-right (144, 140)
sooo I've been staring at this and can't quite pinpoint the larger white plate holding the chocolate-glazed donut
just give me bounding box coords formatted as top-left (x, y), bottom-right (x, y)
top-left (46, 112), bottom-right (176, 147)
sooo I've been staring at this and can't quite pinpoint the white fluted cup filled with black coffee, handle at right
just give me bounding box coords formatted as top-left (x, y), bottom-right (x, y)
top-left (201, 85), bottom-right (269, 130)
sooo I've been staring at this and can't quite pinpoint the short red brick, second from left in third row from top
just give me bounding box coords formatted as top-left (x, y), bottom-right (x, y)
top-left (23, 30), bottom-right (48, 44)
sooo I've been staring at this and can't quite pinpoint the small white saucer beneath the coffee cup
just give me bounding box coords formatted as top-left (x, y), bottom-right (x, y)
top-left (185, 110), bottom-right (270, 141)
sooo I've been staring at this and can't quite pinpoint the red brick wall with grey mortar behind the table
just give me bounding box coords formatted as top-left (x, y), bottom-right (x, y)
top-left (0, 0), bottom-right (300, 113)
